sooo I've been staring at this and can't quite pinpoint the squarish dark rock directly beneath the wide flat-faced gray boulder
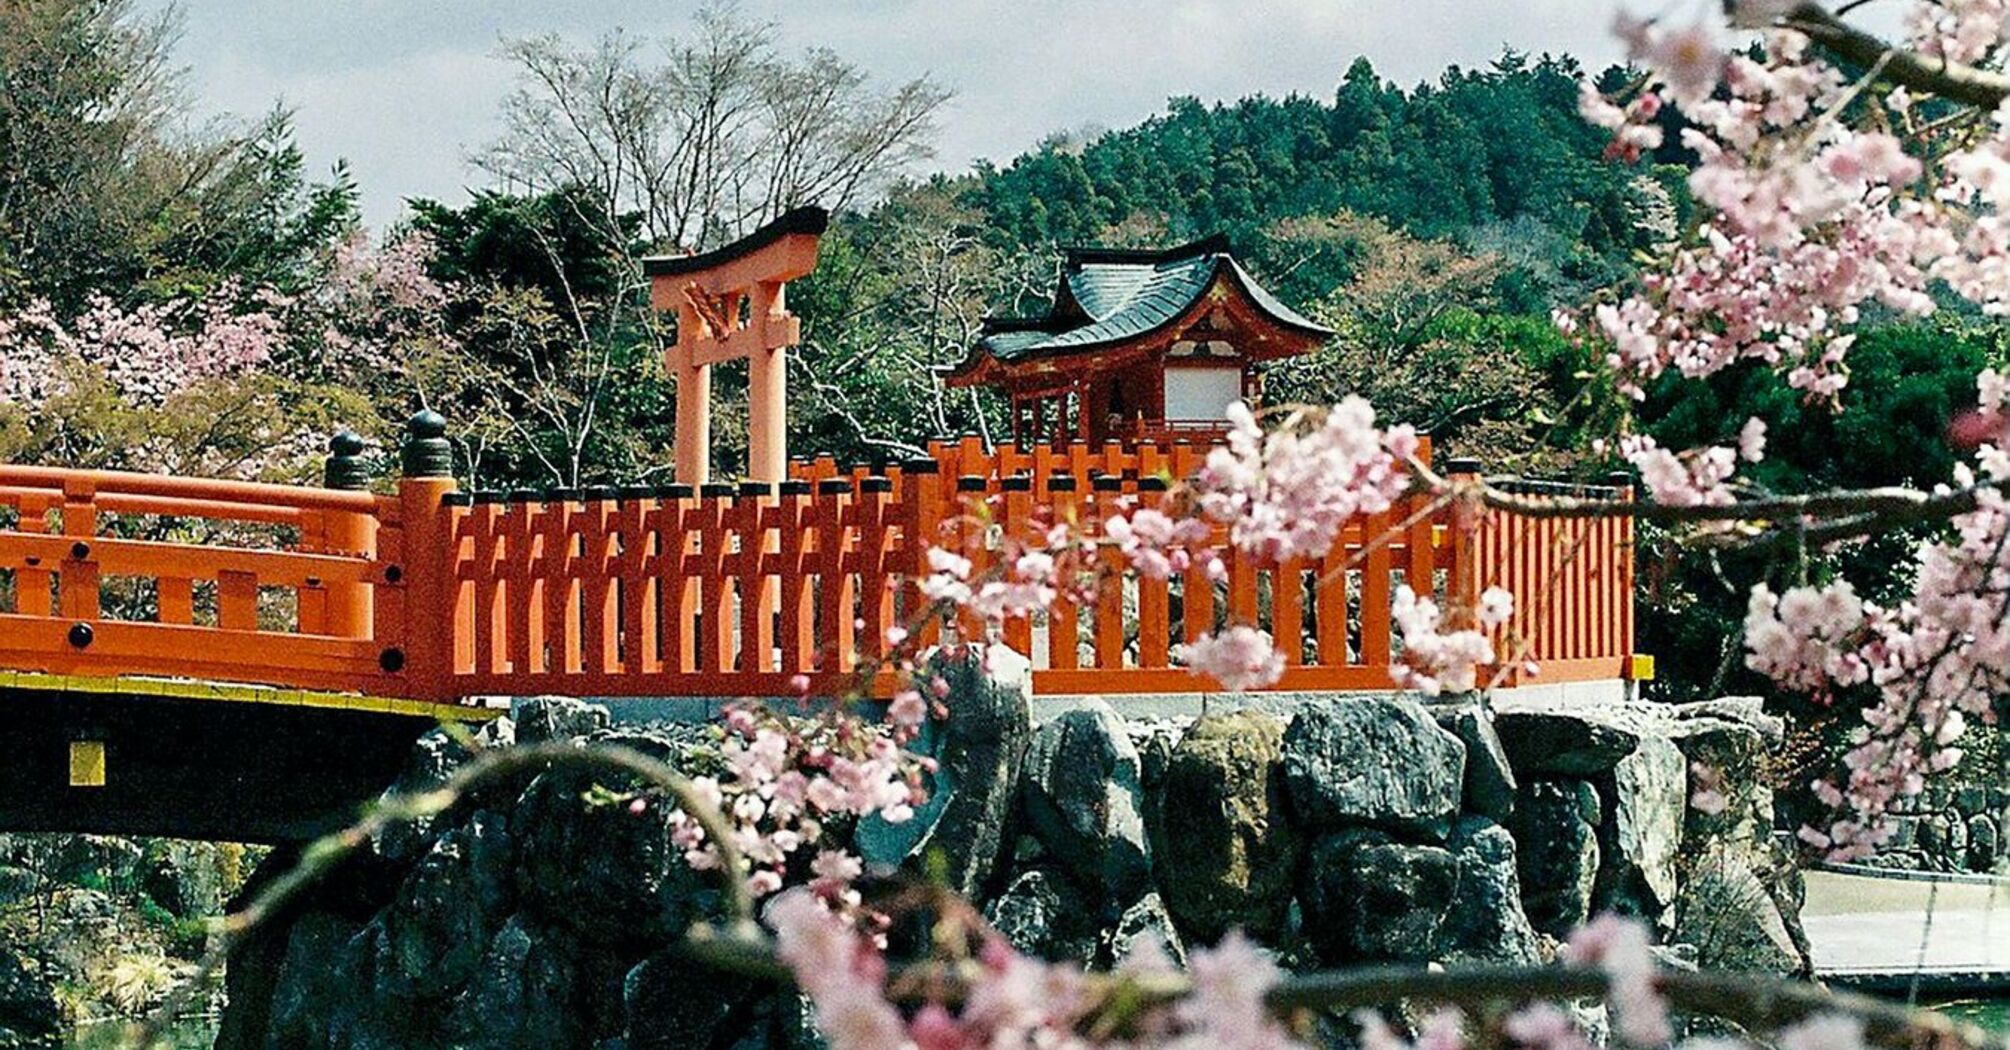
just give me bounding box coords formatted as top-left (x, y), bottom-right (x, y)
top-left (1300, 829), bottom-right (1459, 966)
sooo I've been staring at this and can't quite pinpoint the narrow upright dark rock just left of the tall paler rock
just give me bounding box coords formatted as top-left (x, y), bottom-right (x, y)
top-left (1510, 778), bottom-right (1602, 937)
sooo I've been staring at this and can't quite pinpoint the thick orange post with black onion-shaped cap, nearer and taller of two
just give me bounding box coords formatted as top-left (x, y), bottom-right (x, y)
top-left (393, 410), bottom-right (458, 700)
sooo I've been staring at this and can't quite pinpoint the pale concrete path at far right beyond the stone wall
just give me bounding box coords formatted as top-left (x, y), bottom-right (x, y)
top-left (1801, 871), bottom-right (2010, 980)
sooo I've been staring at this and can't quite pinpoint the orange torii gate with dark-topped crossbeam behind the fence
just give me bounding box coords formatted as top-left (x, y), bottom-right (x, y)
top-left (643, 207), bottom-right (830, 485)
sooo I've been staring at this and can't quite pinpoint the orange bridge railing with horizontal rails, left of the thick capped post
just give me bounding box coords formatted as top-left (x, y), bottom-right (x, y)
top-left (0, 467), bottom-right (404, 690)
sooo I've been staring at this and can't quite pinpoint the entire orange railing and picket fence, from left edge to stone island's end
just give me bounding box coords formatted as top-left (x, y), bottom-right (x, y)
top-left (0, 441), bottom-right (1632, 700)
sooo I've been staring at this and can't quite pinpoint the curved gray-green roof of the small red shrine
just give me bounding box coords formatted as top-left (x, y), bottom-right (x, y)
top-left (957, 235), bottom-right (1333, 374)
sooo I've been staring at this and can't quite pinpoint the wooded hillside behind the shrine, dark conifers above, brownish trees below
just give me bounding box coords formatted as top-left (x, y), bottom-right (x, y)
top-left (792, 52), bottom-right (1680, 468)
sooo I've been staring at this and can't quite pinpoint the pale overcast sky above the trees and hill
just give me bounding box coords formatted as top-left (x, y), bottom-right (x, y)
top-left (152, 0), bottom-right (1616, 225)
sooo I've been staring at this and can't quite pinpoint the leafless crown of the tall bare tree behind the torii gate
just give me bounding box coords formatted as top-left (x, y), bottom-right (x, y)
top-left (486, 6), bottom-right (949, 249)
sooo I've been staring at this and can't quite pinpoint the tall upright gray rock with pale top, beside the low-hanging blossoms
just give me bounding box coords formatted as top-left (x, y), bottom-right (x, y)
top-left (856, 650), bottom-right (1033, 897)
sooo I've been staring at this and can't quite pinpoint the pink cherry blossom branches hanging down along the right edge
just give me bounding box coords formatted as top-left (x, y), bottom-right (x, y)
top-left (1560, 0), bottom-right (2010, 857)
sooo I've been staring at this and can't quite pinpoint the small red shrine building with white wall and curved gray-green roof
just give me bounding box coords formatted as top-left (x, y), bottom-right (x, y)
top-left (947, 235), bottom-right (1333, 447)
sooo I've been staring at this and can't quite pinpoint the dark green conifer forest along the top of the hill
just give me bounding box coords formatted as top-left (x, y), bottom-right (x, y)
top-left (967, 52), bottom-right (1664, 297)
